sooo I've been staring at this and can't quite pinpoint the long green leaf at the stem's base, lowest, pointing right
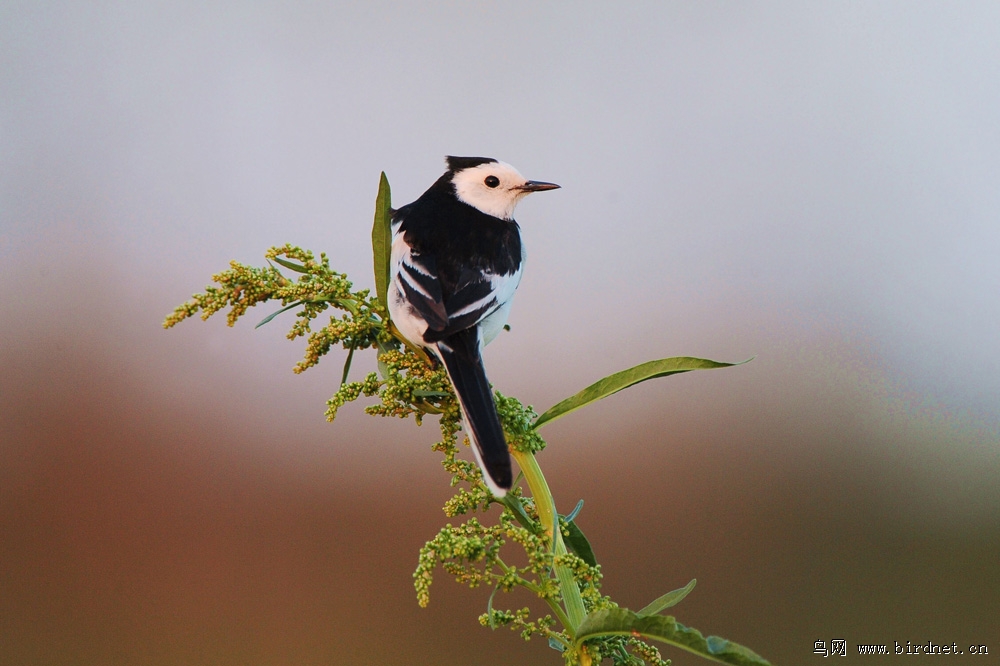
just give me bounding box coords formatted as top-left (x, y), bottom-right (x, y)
top-left (575, 608), bottom-right (771, 666)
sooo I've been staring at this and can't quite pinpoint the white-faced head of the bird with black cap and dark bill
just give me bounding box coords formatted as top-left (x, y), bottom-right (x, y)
top-left (447, 157), bottom-right (559, 220)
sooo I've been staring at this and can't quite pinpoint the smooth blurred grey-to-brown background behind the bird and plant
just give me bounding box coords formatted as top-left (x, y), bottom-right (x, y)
top-left (0, 0), bottom-right (1000, 665)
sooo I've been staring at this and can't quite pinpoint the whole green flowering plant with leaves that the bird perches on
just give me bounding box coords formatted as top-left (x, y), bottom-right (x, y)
top-left (163, 237), bottom-right (769, 666)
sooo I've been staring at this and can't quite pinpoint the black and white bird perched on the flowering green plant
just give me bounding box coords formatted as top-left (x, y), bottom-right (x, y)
top-left (389, 157), bottom-right (559, 497)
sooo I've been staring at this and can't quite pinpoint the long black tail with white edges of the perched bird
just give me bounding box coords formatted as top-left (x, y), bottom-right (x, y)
top-left (437, 326), bottom-right (513, 497)
